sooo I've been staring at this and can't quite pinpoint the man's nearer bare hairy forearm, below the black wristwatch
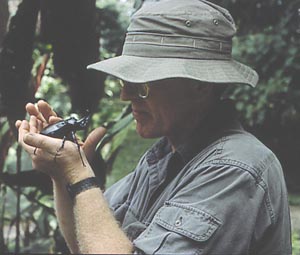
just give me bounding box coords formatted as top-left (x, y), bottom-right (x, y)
top-left (74, 188), bottom-right (132, 254)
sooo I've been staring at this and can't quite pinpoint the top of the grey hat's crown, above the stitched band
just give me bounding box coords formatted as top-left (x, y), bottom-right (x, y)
top-left (127, 0), bottom-right (236, 41)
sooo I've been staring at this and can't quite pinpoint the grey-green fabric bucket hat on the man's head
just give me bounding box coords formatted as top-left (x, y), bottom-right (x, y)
top-left (87, 0), bottom-right (258, 87)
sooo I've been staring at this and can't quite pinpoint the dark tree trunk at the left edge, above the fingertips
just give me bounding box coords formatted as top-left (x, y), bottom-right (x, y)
top-left (0, 0), bottom-right (40, 123)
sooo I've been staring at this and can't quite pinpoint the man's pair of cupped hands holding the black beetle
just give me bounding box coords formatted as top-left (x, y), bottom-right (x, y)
top-left (16, 101), bottom-right (106, 182)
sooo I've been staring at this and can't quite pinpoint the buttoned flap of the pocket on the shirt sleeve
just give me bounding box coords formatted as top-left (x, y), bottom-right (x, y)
top-left (156, 202), bottom-right (221, 242)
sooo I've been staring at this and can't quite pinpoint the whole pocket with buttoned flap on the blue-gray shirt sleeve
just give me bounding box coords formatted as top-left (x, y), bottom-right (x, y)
top-left (133, 202), bottom-right (221, 254)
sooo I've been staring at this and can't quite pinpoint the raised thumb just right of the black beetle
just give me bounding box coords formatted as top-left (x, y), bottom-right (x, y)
top-left (82, 127), bottom-right (106, 161)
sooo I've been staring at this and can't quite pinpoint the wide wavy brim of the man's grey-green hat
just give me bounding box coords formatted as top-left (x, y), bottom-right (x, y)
top-left (87, 55), bottom-right (258, 87)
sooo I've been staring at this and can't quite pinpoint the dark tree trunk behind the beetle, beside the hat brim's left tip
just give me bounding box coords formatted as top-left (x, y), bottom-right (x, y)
top-left (41, 0), bottom-right (105, 115)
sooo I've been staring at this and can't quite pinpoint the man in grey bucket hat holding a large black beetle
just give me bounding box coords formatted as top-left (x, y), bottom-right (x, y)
top-left (16, 0), bottom-right (291, 255)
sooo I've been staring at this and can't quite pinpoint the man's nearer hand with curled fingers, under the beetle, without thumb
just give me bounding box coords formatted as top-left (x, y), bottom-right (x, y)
top-left (19, 116), bottom-right (92, 183)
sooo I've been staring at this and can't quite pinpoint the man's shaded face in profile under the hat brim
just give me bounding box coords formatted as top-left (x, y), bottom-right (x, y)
top-left (121, 79), bottom-right (213, 141)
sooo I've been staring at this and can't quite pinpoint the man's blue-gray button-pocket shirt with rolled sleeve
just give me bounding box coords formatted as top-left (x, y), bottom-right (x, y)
top-left (105, 102), bottom-right (292, 255)
